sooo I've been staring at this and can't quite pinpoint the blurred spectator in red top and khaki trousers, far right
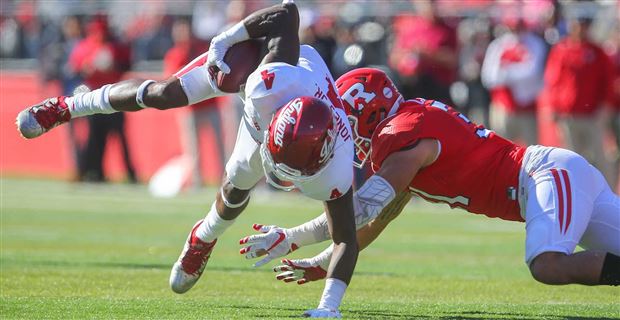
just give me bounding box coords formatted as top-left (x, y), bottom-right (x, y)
top-left (542, 18), bottom-right (613, 182)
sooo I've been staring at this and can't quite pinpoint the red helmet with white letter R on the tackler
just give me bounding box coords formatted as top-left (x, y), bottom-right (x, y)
top-left (336, 68), bottom-right (403, 168)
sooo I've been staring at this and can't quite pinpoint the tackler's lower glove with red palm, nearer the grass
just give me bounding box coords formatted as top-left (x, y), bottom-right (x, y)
top-left (273, 246), bottom-right (333, 284)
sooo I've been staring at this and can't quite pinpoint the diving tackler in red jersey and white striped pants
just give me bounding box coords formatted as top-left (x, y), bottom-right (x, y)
top-left (242, 68), bottom-right (620, 285)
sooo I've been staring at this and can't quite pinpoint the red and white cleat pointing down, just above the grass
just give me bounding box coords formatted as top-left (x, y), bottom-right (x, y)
top-left (170, 220), bottom-right (217, 293)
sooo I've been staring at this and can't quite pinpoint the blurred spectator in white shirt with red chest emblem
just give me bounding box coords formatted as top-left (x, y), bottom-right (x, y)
top-left (482, 17), bottom-right (547, 145)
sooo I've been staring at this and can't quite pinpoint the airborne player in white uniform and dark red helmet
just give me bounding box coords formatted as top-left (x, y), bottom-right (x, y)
top-left (17, 0), bottom-right (358, 317)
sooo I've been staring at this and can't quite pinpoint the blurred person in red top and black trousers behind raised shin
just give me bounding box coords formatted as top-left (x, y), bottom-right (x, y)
top-left (69, 16), bottom-right (136, 182)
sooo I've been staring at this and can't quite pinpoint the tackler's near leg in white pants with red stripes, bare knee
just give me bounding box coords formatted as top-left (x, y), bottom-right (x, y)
top-left (526, 149), bottom-right (606, 285)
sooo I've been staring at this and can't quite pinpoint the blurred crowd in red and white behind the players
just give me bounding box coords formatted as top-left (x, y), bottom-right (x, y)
top-left (0, 0), bottom-right (620, 192)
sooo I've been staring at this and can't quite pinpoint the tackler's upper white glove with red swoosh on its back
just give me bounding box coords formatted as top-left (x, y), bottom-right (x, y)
top-left (239, 223), bottom-right (298, 267)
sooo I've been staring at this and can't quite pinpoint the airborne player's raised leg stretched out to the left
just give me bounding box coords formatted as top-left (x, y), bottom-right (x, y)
top-left (16, 53), bottom-right (223, 139)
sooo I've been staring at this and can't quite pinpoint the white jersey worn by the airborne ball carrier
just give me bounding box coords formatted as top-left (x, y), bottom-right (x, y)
top-left (229, 45), bottom-right (353, 201)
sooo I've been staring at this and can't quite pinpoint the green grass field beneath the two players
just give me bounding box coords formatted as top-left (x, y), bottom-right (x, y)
top-left (0, 179), bottom-right (620, 319)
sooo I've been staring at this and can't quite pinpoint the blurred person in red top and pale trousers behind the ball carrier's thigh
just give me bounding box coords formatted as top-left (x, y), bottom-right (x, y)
top-left (164, 19), bottom-right (227, 190)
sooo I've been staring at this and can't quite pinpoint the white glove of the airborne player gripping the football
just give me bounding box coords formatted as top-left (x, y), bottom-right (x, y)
top-left (207, 21), bottom-right (250, 74)
